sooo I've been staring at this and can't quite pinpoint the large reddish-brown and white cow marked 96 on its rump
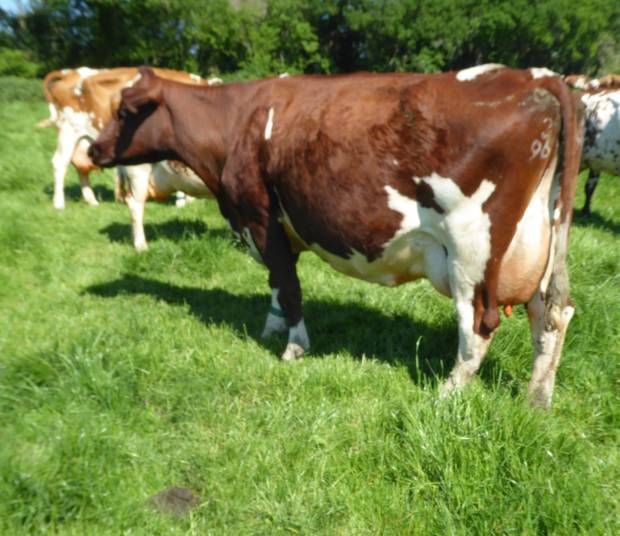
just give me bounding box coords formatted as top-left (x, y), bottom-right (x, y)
top-left (90, 65), bottom-right (582, 406)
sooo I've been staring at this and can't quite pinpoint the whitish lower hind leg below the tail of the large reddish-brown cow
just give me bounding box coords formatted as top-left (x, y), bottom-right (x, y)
top-left (527, 292), bottom-right (575, 409)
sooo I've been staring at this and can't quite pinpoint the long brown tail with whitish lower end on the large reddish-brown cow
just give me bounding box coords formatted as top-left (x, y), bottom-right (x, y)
top-left (540, 76), bottom-right (584, 322)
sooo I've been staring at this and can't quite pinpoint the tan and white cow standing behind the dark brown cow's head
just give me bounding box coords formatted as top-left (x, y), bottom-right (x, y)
top-left (40, 67), bottom-right (221, 250)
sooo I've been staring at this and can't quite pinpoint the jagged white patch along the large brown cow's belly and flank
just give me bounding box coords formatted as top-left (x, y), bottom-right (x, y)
top-left (282, 174), bottom-right (495, 296)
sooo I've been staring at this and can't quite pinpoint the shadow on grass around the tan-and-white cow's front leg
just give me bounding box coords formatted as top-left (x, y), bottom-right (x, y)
top-left (99, 219), bottom-right (233, 244)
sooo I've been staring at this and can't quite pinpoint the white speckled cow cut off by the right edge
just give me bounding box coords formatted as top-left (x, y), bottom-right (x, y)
top-left (566, 75), bottom-right (620, 216)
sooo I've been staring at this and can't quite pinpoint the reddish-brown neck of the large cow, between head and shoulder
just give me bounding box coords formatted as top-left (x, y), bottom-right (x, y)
top-left (165, 84), bottom-right (250, 196)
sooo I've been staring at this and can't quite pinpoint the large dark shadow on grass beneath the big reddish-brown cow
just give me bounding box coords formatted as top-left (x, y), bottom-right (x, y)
top-left (86, 275), bottom-right (464, 383)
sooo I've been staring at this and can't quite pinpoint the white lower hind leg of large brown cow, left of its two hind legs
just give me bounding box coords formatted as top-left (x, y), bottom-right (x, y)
top-left (440, 291), bottom-right (492, 397)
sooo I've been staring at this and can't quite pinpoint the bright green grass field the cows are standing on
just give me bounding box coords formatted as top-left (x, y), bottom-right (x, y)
top-left (0, 91), bottom-right (620, 535)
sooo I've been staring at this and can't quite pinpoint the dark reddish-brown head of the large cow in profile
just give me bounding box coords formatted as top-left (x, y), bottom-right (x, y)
top-left (88, 67), bottom-right (175, 167)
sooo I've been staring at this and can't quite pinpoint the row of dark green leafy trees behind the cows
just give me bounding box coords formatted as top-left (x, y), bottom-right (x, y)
top-left (0, 0), bottom-right (620, 78)
